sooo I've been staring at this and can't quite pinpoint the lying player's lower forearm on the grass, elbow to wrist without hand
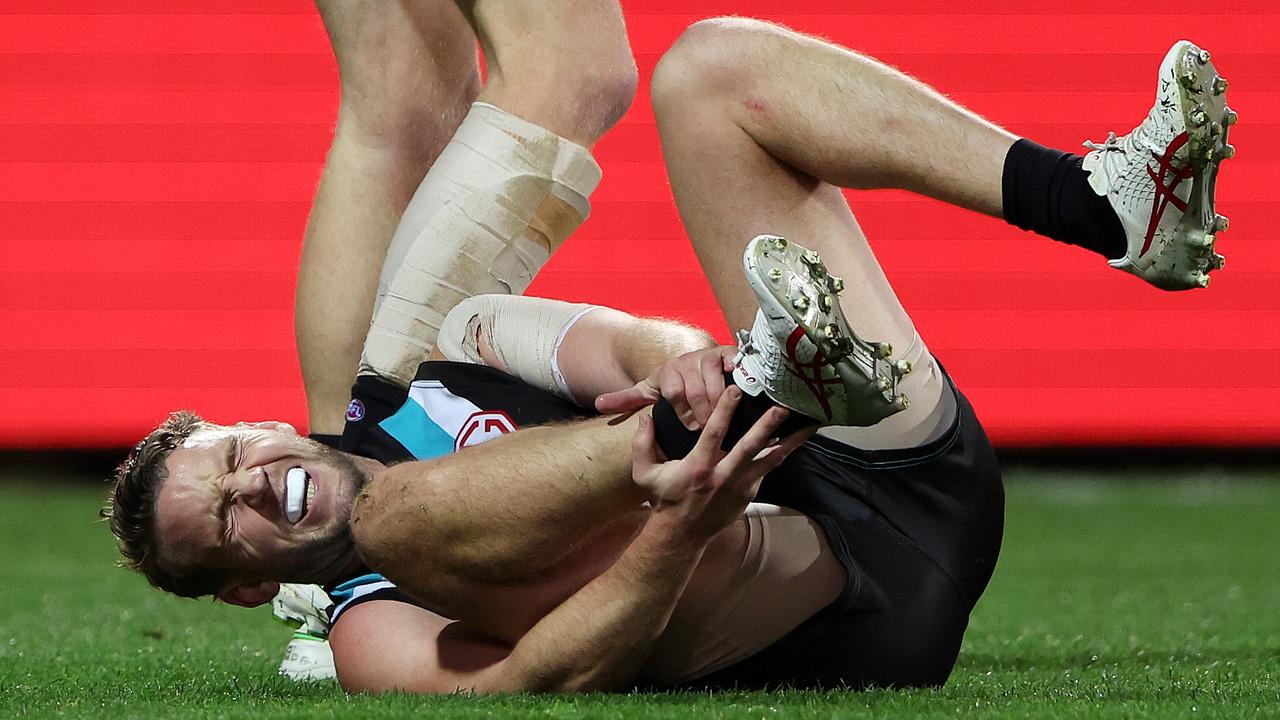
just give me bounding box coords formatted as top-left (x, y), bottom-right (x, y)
top-left (497, 510), bottom-right (707, 692)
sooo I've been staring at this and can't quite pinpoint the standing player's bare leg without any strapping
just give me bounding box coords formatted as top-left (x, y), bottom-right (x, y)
top-left (294, 0), bottom-right (479, 433)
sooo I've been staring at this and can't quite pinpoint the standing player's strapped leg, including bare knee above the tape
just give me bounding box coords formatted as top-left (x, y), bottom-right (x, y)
top-left (361, 0), bottom-right (636, 384)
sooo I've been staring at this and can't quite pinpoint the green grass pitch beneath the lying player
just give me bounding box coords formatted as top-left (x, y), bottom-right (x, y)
top-left (0, 468), bottom-right (1280, 719)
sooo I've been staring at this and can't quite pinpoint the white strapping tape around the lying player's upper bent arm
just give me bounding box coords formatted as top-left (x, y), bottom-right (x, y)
top-left (436, 295), bottom-right (600, 401)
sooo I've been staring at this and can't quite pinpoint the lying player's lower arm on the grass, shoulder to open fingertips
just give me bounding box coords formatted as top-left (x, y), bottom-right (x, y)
top-left (334, 388), bottom-right (809, 693)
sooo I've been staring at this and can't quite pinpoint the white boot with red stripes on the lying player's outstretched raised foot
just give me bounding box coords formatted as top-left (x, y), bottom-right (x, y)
top-left (1084, 40), bottom-right (1236, 290)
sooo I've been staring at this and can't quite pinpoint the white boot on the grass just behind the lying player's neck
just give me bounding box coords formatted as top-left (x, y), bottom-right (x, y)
top-left (271, 583), bottom-right (338, 682)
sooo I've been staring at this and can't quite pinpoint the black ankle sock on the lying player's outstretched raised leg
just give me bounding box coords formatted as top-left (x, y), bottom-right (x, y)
top-left (1004, 140), bottom-right (1128, 259)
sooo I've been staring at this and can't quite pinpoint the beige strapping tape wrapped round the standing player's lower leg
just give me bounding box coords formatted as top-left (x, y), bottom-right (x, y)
top-left (360, 102), bottom-right (600, 384)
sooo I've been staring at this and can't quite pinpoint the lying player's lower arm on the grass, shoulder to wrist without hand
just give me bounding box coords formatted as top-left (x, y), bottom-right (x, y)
top-left (330, 514), bottom-right (707, 693)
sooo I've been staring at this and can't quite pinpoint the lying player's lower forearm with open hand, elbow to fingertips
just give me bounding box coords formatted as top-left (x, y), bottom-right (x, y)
top-left (476, 388), bottom-right (812, 692)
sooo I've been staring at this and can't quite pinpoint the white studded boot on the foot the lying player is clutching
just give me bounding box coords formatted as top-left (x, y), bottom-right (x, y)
top-left (733, 234), bottom-right (911, 427)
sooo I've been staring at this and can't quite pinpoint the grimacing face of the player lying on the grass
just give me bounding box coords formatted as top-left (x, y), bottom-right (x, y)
top-left (155, 423), bottom-right (367, 605)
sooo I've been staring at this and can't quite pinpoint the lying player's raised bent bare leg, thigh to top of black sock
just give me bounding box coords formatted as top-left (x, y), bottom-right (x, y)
top-left (653, 18), bottom-right (1015, 438)
